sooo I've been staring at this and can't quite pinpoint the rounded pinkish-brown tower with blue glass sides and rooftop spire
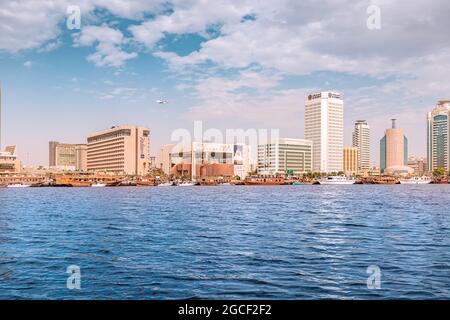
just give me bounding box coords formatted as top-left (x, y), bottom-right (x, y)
top-left (380, 119), bottom-right (409, 173)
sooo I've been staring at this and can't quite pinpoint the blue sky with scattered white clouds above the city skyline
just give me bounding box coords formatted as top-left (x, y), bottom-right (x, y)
top-left (0, 0), bottom-right (450, 165)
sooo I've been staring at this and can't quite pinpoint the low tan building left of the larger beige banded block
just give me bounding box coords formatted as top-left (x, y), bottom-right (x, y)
top-left (48, 141), bottom-right (87, 171)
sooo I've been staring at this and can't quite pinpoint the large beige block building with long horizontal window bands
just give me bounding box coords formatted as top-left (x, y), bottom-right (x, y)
top-left (87, 125), bottom-right (150, 175)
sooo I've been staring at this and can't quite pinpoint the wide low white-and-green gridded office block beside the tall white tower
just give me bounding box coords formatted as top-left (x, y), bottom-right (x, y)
top-left (258, 138), bottom-right (313, 175)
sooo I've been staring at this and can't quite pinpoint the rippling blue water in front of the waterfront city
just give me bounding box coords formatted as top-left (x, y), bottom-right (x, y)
top-left (0, 185), bottom-right (450, 299)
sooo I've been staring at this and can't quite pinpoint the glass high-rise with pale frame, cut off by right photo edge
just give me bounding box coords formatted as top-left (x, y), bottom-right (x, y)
top-left (427, 100), bottom-right (450, 171)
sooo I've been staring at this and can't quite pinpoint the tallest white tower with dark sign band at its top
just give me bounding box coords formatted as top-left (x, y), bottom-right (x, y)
top-left (305, 92), bottom-right (344, 172)
